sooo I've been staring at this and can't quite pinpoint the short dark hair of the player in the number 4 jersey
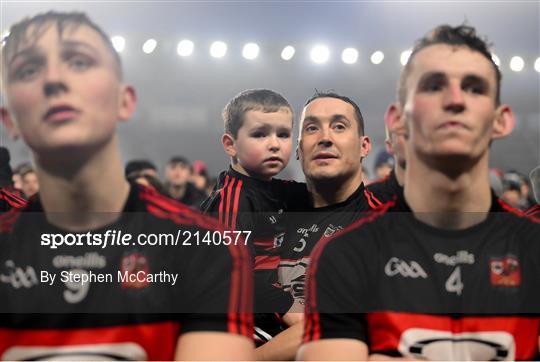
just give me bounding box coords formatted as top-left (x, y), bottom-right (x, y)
top-left (398, 24), bottom-right (502, 105)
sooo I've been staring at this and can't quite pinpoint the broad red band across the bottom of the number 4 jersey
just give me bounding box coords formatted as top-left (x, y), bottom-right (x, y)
top-left (366, 312), bottom-right (540, 360)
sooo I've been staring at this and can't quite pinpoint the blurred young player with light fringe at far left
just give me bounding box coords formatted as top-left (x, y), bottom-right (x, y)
top-left (0, 12), bottom-right (253, 360)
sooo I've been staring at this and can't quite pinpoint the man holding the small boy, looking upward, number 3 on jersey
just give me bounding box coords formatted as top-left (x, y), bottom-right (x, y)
top-left (279, 93), bottom-right (378, 304)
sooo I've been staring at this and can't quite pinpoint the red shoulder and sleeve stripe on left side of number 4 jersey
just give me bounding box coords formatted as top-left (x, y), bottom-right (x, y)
top-left (304, 201), bottom-right (394, 343)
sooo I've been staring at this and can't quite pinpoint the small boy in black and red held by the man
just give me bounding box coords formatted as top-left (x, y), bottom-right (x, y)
top-left (202, 89), bottom-right (307, 360)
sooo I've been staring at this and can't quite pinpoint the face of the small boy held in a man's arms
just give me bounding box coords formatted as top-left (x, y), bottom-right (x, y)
top-left (234, 107), bottom-right (292, 180)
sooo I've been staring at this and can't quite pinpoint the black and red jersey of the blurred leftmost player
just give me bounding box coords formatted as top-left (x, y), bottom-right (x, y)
top-left (0, 185), bottom-right (253, 360)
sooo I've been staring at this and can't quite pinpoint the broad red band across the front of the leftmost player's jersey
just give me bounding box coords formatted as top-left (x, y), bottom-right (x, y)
top-left (0, 316), bottom-right (179, 360)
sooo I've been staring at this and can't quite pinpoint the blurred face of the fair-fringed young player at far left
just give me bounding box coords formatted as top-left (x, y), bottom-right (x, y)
top-left (2, 23), bottom-right (135, 153)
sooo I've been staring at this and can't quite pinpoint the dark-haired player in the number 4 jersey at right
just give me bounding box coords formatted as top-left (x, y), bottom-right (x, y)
top-left (300, 26), bottom-right (540, 360)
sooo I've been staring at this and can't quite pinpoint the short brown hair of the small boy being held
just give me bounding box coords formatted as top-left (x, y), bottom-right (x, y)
top-left (222, 89), bottom-right (294, 138)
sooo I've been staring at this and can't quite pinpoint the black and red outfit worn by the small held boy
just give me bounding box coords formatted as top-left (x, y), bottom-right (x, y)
top-left (202, 168), bottom-right (308, 343)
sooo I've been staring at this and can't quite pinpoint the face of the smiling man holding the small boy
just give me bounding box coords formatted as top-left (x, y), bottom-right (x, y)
top-left (298, 98), bottom-right (370, 182)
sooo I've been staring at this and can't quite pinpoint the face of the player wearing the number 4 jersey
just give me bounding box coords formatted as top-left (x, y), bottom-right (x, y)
top-left (404, 44), bottom-right (496, 159)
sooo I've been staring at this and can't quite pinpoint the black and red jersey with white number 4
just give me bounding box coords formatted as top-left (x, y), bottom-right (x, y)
top-left (304, 197), bottom-right (540, 360)
